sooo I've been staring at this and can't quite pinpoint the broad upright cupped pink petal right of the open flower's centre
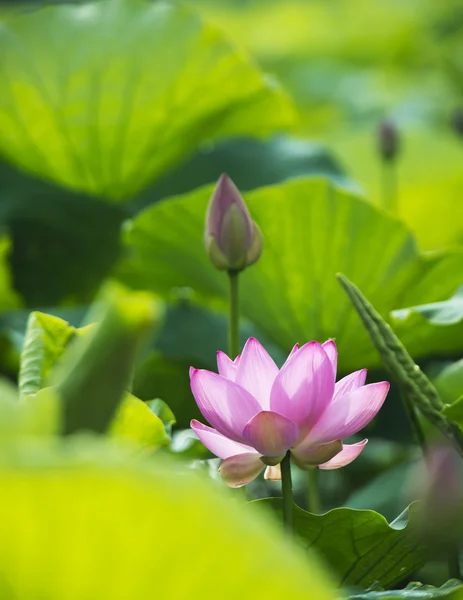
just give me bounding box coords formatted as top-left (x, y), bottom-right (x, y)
top-left (270, 342), bottom-right (335, 432)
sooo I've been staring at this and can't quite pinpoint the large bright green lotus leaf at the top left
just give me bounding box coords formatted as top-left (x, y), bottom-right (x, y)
top-left (0, 0), bottom-right (293, 199)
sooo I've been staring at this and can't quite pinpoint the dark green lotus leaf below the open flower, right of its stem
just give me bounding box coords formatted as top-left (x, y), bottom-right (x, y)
top-left (253, 498), bottom-right (426, 588)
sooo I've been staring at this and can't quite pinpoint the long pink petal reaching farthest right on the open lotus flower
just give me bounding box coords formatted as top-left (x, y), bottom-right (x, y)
top-left (304, 381), bottom-right (389, 444)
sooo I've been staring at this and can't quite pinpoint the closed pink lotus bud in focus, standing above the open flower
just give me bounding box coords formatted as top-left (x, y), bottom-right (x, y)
top-left (205, 175), bottom-right (263, 271)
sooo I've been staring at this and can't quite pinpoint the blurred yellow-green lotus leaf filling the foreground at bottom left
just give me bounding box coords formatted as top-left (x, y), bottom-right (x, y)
top-left (0, 438), bottom-right (336, 600)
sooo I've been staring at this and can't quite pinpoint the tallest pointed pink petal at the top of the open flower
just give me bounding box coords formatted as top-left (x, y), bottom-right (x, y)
top-left (235, 338), bottom-right (278, 409)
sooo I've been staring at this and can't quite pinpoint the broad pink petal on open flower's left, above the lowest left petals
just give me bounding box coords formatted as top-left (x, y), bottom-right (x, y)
top-left (190, 369), bottom-right (261, 442)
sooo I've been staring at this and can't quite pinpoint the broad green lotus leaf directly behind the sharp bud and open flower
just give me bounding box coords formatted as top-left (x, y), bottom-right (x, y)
top-left (119, 179), bottom-right (463, 371)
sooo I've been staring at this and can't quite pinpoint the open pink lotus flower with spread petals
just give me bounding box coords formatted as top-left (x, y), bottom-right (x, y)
top-left (190, 338), bottom-right (389, 487)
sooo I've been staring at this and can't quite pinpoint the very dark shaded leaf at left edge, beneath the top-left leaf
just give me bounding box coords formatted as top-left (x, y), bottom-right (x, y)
top-left (0, 162), bottom-right (128, 307)
